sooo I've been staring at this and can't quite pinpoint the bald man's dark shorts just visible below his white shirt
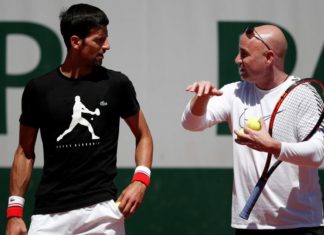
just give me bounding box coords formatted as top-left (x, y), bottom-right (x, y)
top-left (235, 227), bottom-right (324, 235)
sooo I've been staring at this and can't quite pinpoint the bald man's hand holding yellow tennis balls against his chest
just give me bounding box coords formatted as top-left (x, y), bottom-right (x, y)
top-left (234, 118), bottom-right (281, 156)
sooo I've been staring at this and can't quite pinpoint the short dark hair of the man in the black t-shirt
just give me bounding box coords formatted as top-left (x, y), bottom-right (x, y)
top-left (60, 3), bottom-right (109, 49)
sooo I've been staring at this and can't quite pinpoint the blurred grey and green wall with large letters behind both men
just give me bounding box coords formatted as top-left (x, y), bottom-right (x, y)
top-left (0, 0), bottom-right (324, 235)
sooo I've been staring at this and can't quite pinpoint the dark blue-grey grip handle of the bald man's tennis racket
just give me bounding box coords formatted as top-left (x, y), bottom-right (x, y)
top-left (240, 177), bottom-right (267, 220)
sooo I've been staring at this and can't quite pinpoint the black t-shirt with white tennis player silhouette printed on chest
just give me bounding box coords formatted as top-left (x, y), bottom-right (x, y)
top-left (20, 67), bottom-right (140, 214)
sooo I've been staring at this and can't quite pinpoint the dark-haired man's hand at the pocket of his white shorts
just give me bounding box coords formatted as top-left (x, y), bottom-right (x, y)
top-left (117, 181), bottom-right (146, 218)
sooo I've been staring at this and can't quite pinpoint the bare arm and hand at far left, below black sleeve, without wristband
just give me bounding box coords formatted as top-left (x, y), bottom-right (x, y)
top-left (6, 125), bottom-right (38, 235)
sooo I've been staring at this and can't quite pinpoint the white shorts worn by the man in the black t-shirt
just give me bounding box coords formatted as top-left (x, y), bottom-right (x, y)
top-left (28, 200), bottom-right (125, 235)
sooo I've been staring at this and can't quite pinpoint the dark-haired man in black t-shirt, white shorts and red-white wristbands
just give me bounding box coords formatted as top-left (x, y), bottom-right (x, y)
top-left (7, 4), bottom-right (153, 235)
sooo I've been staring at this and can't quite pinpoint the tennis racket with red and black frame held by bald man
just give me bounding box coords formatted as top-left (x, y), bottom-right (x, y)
top-left (240, 78), bottom-right (324, 220)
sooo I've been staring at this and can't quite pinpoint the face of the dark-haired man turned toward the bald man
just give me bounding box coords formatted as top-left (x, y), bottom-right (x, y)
top-left (80, 27), bottom-right (110, 66)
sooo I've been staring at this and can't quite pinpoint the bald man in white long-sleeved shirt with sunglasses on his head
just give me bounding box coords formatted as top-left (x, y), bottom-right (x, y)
top-left (182, 25), bottom-right (324, 235)
